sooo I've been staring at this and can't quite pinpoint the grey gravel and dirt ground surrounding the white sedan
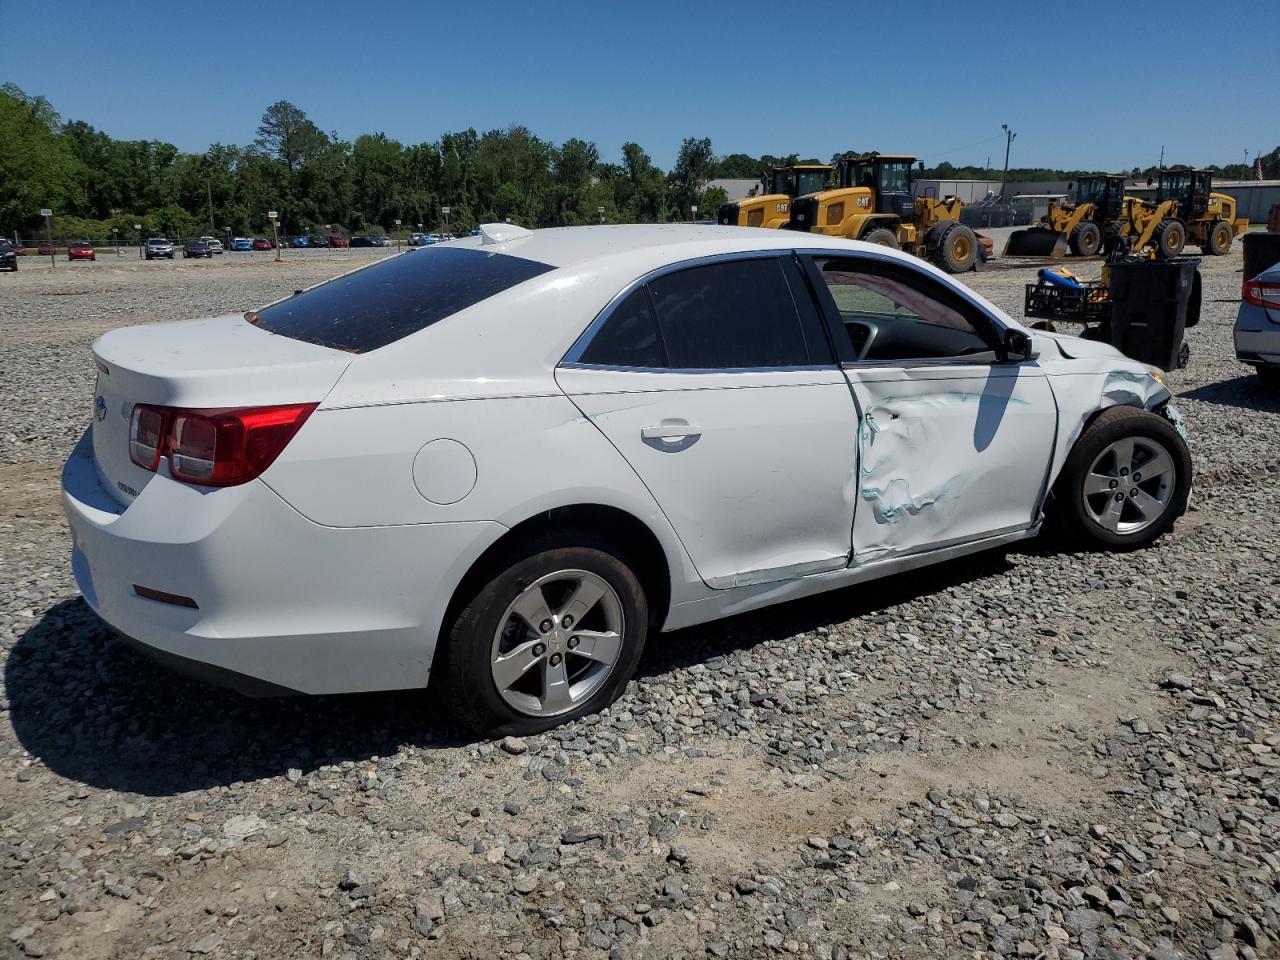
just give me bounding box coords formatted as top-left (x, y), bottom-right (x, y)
top-left (0, 248), bottom-right (1280, 960)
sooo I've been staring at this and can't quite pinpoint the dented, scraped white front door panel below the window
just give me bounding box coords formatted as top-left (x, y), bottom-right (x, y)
top-left (847, 364), bottom-right (1056, 564)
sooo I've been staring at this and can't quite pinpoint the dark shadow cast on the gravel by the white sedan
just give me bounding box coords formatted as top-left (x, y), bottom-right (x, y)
top-left (5, 552), bottom-right (1009, 796)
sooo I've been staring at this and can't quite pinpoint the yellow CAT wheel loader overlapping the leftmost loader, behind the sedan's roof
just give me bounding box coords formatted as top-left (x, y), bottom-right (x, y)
top-left (788, 152), bottom-right (979, 274)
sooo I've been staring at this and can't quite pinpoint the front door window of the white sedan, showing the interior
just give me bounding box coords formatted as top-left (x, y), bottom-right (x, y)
top-left (817, 259), bottom-right (996, 362)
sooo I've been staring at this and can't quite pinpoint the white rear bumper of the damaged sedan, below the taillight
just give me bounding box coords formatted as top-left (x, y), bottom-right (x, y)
top-left (63, 433), bottom-right (506, 694)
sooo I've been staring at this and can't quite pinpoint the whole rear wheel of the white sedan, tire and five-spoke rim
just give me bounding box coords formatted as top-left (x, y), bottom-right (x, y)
top-left (450, 547), bottom-right (649, 736)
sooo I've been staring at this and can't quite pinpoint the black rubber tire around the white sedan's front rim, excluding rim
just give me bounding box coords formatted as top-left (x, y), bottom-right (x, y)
top-left (1052, 407), bottom-right (1192, 550)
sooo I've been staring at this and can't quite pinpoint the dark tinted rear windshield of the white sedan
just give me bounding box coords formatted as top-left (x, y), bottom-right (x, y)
top-left (244, 248), bottom-right (556, 353)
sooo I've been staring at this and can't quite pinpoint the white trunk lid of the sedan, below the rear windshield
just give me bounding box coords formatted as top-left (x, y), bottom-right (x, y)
top-left (92, 314), bottom-right (352, 507)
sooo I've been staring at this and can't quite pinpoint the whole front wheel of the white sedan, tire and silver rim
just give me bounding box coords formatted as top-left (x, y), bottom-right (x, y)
top-left (1053, 407), bottom-right (1192, 550)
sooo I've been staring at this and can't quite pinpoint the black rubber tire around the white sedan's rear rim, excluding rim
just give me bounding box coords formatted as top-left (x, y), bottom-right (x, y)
top-left (435, 536), bottom-right (649, 736)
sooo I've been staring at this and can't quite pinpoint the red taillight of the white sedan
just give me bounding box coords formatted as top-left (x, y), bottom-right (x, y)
top-left (129, 403), bottom-right (316, 486)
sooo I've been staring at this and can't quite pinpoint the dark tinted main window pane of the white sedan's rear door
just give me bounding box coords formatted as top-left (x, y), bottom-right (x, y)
top-left (649, 257), bottom-right (810, 370)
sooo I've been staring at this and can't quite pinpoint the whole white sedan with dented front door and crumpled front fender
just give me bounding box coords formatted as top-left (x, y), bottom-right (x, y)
top-left (63, 224), bottom-right (1192, 732)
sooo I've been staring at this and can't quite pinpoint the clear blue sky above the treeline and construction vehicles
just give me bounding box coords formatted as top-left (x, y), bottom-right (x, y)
top-left (0, 0), bottom-right (1280, 169)
